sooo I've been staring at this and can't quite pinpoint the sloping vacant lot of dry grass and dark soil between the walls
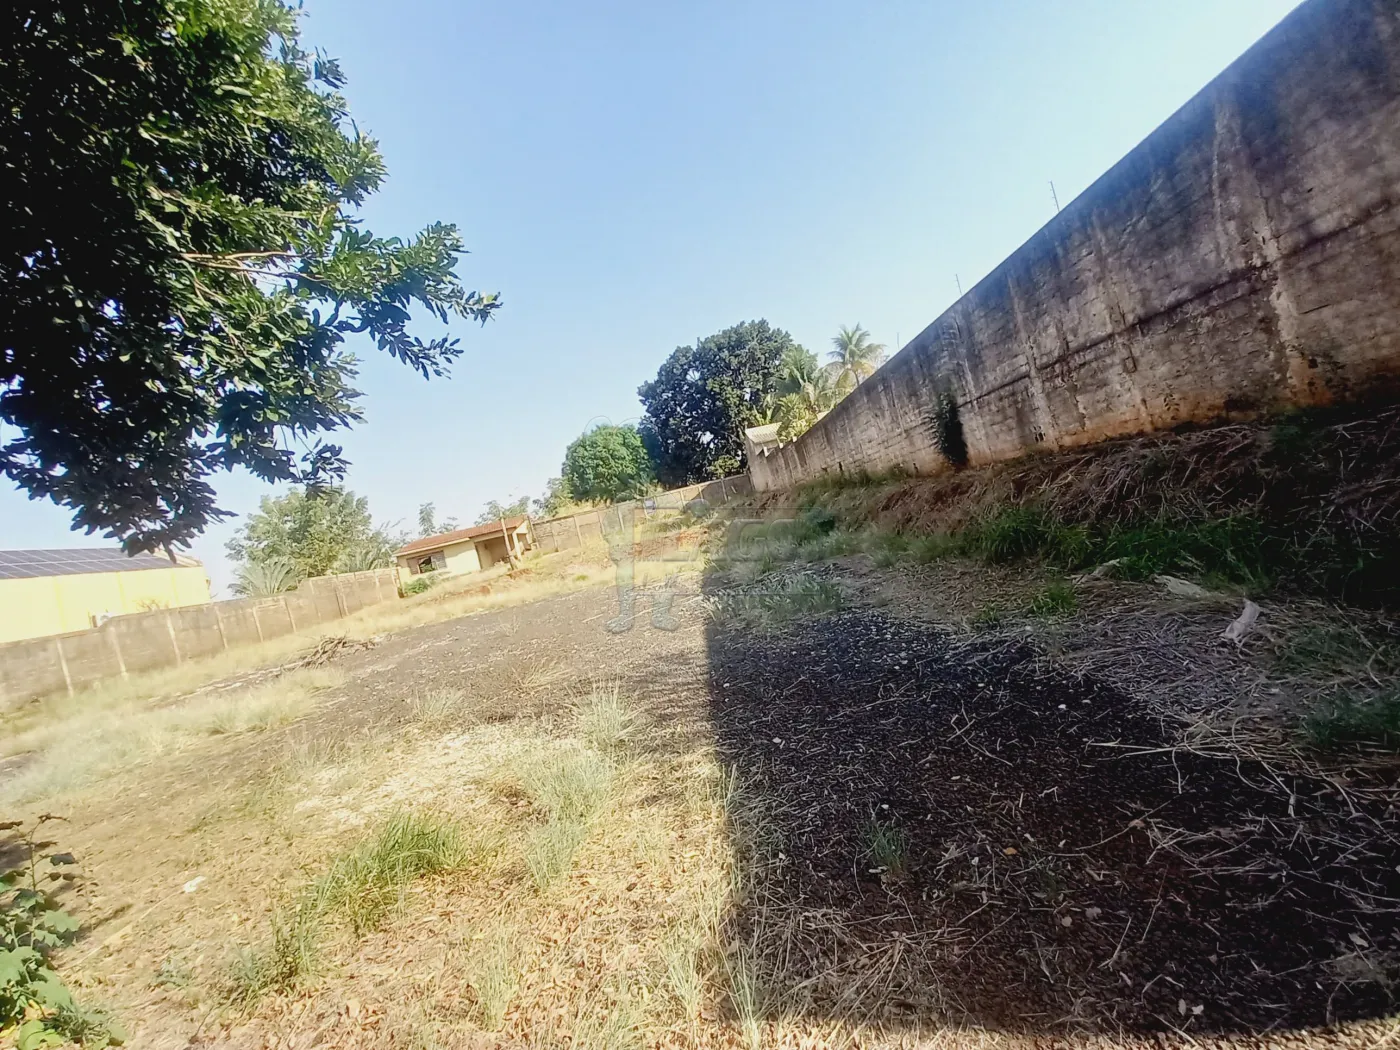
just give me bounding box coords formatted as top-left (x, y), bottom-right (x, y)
top-left (0, 526), bottom-right (1400, 1049)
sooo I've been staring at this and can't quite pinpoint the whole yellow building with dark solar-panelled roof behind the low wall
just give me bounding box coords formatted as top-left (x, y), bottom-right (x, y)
top-left (0, 547), bottom-right (209, 641)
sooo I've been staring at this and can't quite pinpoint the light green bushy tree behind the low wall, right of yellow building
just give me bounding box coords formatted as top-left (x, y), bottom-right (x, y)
top-left (227, 487), bottom-right (399, 589)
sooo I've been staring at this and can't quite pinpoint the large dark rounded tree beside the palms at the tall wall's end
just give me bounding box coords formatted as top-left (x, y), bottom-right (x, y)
top-left (637, 321), bottom-right (797, 486)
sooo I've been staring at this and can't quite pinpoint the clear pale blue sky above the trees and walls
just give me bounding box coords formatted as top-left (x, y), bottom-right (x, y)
top-left (0, 0), bottom-right (1295, 589)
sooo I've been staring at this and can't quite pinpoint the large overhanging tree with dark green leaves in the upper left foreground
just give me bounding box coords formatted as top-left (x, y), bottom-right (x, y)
top-left (0, 0), bottom-right (498, 552)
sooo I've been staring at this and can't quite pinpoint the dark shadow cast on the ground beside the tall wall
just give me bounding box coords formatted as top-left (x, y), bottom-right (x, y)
top-left (707, 580), bottom-right (1400, 1033)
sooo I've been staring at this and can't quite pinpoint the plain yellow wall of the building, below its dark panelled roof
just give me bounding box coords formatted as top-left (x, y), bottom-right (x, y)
top-left (0, 564), bottom-right (209, 643)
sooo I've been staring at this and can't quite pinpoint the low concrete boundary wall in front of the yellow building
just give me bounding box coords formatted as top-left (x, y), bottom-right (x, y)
top-left (0, 568), bottom-right (399, 710)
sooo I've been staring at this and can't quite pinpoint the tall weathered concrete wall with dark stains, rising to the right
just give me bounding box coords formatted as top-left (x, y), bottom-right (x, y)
top-left (749, 0), bottom-right (1400, 490)
